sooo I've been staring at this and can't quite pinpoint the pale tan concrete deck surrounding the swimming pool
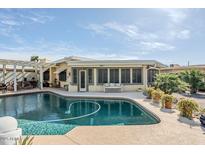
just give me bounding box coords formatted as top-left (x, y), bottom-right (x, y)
top-left (0, 88), bottom-right (205, 145)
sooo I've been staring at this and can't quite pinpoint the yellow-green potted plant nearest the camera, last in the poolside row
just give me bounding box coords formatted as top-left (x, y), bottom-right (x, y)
top-left (177, 98), bottom-right (199, 120)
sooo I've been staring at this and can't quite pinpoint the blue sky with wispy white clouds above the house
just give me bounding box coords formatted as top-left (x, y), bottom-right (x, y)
top-left (0, 8), bottom-right (205, 65)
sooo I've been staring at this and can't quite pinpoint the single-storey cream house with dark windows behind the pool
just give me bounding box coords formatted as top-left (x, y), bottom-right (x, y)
top-left (43, 56), bottom-right (166, 92)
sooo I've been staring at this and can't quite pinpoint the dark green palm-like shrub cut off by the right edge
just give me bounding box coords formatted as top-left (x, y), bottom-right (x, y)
top-left (179, 70), bottom-right (205, 93)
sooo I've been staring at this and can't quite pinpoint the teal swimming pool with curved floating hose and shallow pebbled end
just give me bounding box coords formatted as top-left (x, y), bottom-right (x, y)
top-left (0, 93), bottom-right (159, 135)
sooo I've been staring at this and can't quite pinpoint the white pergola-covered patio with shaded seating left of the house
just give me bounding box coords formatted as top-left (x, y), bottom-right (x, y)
top-left (0, 59), bottom-right (45, 92)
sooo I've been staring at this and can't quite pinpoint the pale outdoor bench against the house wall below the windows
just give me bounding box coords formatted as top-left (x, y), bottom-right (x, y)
top-left (104, 83), bottom-right (122, 93)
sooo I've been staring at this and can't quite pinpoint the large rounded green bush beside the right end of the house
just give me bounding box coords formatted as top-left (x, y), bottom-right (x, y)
top-left (154, 74), bottom-right (188, 94)
